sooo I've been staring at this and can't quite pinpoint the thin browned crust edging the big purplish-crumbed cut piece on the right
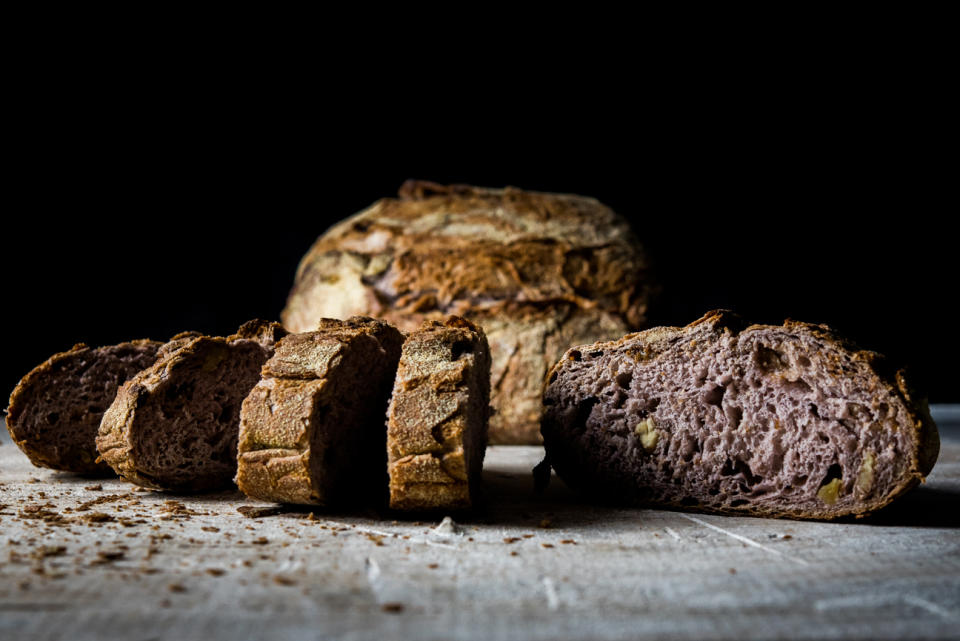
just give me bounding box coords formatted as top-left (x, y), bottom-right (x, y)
top-left (542, 310), bottom-right (940, 520)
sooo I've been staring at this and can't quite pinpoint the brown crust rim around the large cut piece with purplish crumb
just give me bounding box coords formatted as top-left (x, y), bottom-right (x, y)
top-left (534, 310), bottom-right (940, 519)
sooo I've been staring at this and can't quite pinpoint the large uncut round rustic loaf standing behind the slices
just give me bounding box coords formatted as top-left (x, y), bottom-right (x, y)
top-left (282, 181), bottom-right (650, 443)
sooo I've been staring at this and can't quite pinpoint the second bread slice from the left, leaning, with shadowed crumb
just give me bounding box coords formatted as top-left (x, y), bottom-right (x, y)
top-left (97, 321), bottom-right (286, 491)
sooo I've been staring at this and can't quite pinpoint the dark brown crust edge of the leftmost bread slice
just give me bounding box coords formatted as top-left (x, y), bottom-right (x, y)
top-left (6, 339), bottom-right (162, 475)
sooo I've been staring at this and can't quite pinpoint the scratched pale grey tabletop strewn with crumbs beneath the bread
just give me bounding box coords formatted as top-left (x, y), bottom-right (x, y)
top-left (0, 406), bottom-right (960, 641)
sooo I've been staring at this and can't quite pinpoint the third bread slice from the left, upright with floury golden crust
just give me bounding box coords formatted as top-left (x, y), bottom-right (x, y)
top-left (237, 316), bottom-right (403, 505)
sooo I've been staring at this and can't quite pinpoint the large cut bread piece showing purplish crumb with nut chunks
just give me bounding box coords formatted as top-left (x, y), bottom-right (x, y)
top-left (541, 312), bottom-right (939, 519)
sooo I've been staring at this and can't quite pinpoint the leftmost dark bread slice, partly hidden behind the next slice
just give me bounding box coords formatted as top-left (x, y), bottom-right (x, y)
top-left (7, 340), bottom-right (163, 474)
